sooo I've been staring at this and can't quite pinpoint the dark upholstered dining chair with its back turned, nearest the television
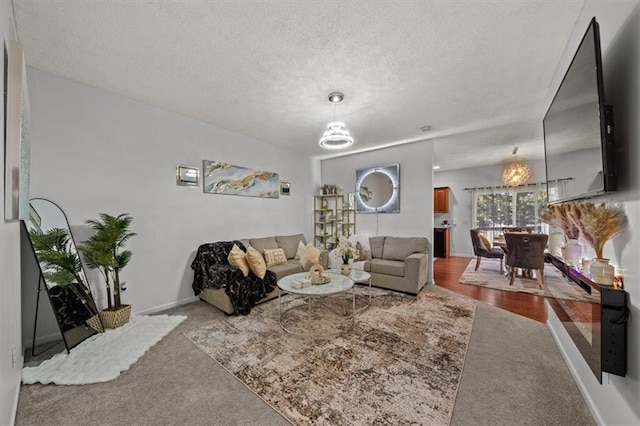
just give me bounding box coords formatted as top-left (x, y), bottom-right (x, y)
top-left (504, 232), bottom-right (549, 289)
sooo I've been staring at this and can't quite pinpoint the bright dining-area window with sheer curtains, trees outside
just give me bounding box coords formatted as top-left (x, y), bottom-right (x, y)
top-left (471, 184), bottom-right (547, 237)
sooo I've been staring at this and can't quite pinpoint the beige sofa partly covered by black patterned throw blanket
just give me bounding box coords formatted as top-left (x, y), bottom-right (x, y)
top-left (198, 234), bottom-right (329, 315)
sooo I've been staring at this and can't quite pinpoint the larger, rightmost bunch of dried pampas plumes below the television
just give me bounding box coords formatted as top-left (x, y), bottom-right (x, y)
top-left (569, 202), bottom-right (628, 259)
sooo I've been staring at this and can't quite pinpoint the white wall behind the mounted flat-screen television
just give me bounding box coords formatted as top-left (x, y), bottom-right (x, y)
top-left (547, 1), bottom-right (640, 425)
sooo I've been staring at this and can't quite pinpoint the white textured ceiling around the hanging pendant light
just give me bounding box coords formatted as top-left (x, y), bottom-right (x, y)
top-left (13, 0), bottom-right (584, 170)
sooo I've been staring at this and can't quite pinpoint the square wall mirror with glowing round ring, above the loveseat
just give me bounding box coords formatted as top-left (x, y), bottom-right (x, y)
top-left (355, 164), bottom-right (400, 213)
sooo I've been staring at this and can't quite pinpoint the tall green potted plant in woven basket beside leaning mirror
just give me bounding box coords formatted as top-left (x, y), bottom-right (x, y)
top-left (80, 213), bottom-right (136, 328)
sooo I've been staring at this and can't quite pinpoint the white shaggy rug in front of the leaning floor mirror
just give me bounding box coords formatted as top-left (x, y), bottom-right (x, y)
top-left (22, 315), bottom-right (187, 385)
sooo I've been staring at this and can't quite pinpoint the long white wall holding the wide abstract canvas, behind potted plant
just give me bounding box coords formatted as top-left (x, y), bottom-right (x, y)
top-left (28, 69), bottom-right (315, 320)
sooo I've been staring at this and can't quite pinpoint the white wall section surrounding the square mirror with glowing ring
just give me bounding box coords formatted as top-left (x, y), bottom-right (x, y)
top-left (321, 141), bottom-right (434, 281)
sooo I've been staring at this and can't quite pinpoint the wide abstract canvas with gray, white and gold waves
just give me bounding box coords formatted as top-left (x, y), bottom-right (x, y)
top-left (202, 160), bottom-right (280, 198)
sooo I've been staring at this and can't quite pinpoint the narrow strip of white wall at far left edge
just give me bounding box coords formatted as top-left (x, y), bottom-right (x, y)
top-left (0, 1), bottom-right (22, 425)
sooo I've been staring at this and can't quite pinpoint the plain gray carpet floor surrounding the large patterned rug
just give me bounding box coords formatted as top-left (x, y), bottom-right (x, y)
top-left (16, 286), bottom-right (595, 425)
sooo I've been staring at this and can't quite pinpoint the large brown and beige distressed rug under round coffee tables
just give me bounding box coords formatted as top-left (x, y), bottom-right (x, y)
top-left (186, 287), bottom-right (476, 425)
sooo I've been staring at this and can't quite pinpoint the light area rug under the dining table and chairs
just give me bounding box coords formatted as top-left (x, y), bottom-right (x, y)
top-left (458, 258), bottom-right (600, 303)
